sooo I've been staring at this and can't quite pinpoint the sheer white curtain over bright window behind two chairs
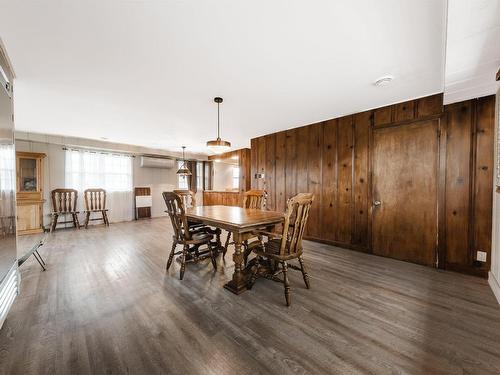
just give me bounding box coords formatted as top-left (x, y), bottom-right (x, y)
top-left (65, 150), bottom-right (134, 222)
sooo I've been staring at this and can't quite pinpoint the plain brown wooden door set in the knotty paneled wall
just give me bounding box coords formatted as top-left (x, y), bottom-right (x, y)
top-left (372, 120), bottom-right (439, 266)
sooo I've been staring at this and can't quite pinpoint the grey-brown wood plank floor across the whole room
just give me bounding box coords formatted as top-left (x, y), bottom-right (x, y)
top-left (0, 218), bottom-right (500, 374)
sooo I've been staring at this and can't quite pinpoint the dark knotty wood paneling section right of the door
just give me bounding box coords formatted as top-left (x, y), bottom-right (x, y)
top-left (445, 96), bottom-right (495, 275)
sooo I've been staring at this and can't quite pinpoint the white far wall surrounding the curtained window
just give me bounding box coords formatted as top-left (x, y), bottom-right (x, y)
top-left (16, 133), bottom-right (206, 226)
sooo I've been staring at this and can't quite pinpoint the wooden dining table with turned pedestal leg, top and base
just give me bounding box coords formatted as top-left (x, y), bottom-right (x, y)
top-left (186, 206), bottom-right (283, 294)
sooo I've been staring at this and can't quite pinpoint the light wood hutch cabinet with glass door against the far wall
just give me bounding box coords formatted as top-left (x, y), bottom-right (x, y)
top-left (16, 152), bottom-right (46, 235)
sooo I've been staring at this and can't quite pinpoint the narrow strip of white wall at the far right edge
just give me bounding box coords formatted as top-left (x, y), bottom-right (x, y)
top-left (488, 87), bottom-right (500, 303)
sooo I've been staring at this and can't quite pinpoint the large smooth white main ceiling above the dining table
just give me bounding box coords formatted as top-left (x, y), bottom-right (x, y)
top-left (0, 0), bottom-right (446, 151)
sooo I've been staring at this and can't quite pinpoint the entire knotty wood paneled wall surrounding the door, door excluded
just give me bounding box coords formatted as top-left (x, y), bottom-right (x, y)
top-left (251, 94), bottom-right (495, 275)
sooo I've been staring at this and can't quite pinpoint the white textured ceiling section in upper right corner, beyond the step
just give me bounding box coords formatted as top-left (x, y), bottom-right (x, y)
top-left (444, 0), bottom-right (500, 103)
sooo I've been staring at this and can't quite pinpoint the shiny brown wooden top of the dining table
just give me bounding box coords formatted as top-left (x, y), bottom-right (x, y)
top-left (186, 206), bottom-right (284, 231)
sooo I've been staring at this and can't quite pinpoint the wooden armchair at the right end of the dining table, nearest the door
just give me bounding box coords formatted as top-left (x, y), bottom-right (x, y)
top-left (248, 193), bottom-right (314, 306)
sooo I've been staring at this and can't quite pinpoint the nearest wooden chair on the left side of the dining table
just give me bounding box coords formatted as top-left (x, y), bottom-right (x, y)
top-left (162, 191), bottom-right (217, 280)
